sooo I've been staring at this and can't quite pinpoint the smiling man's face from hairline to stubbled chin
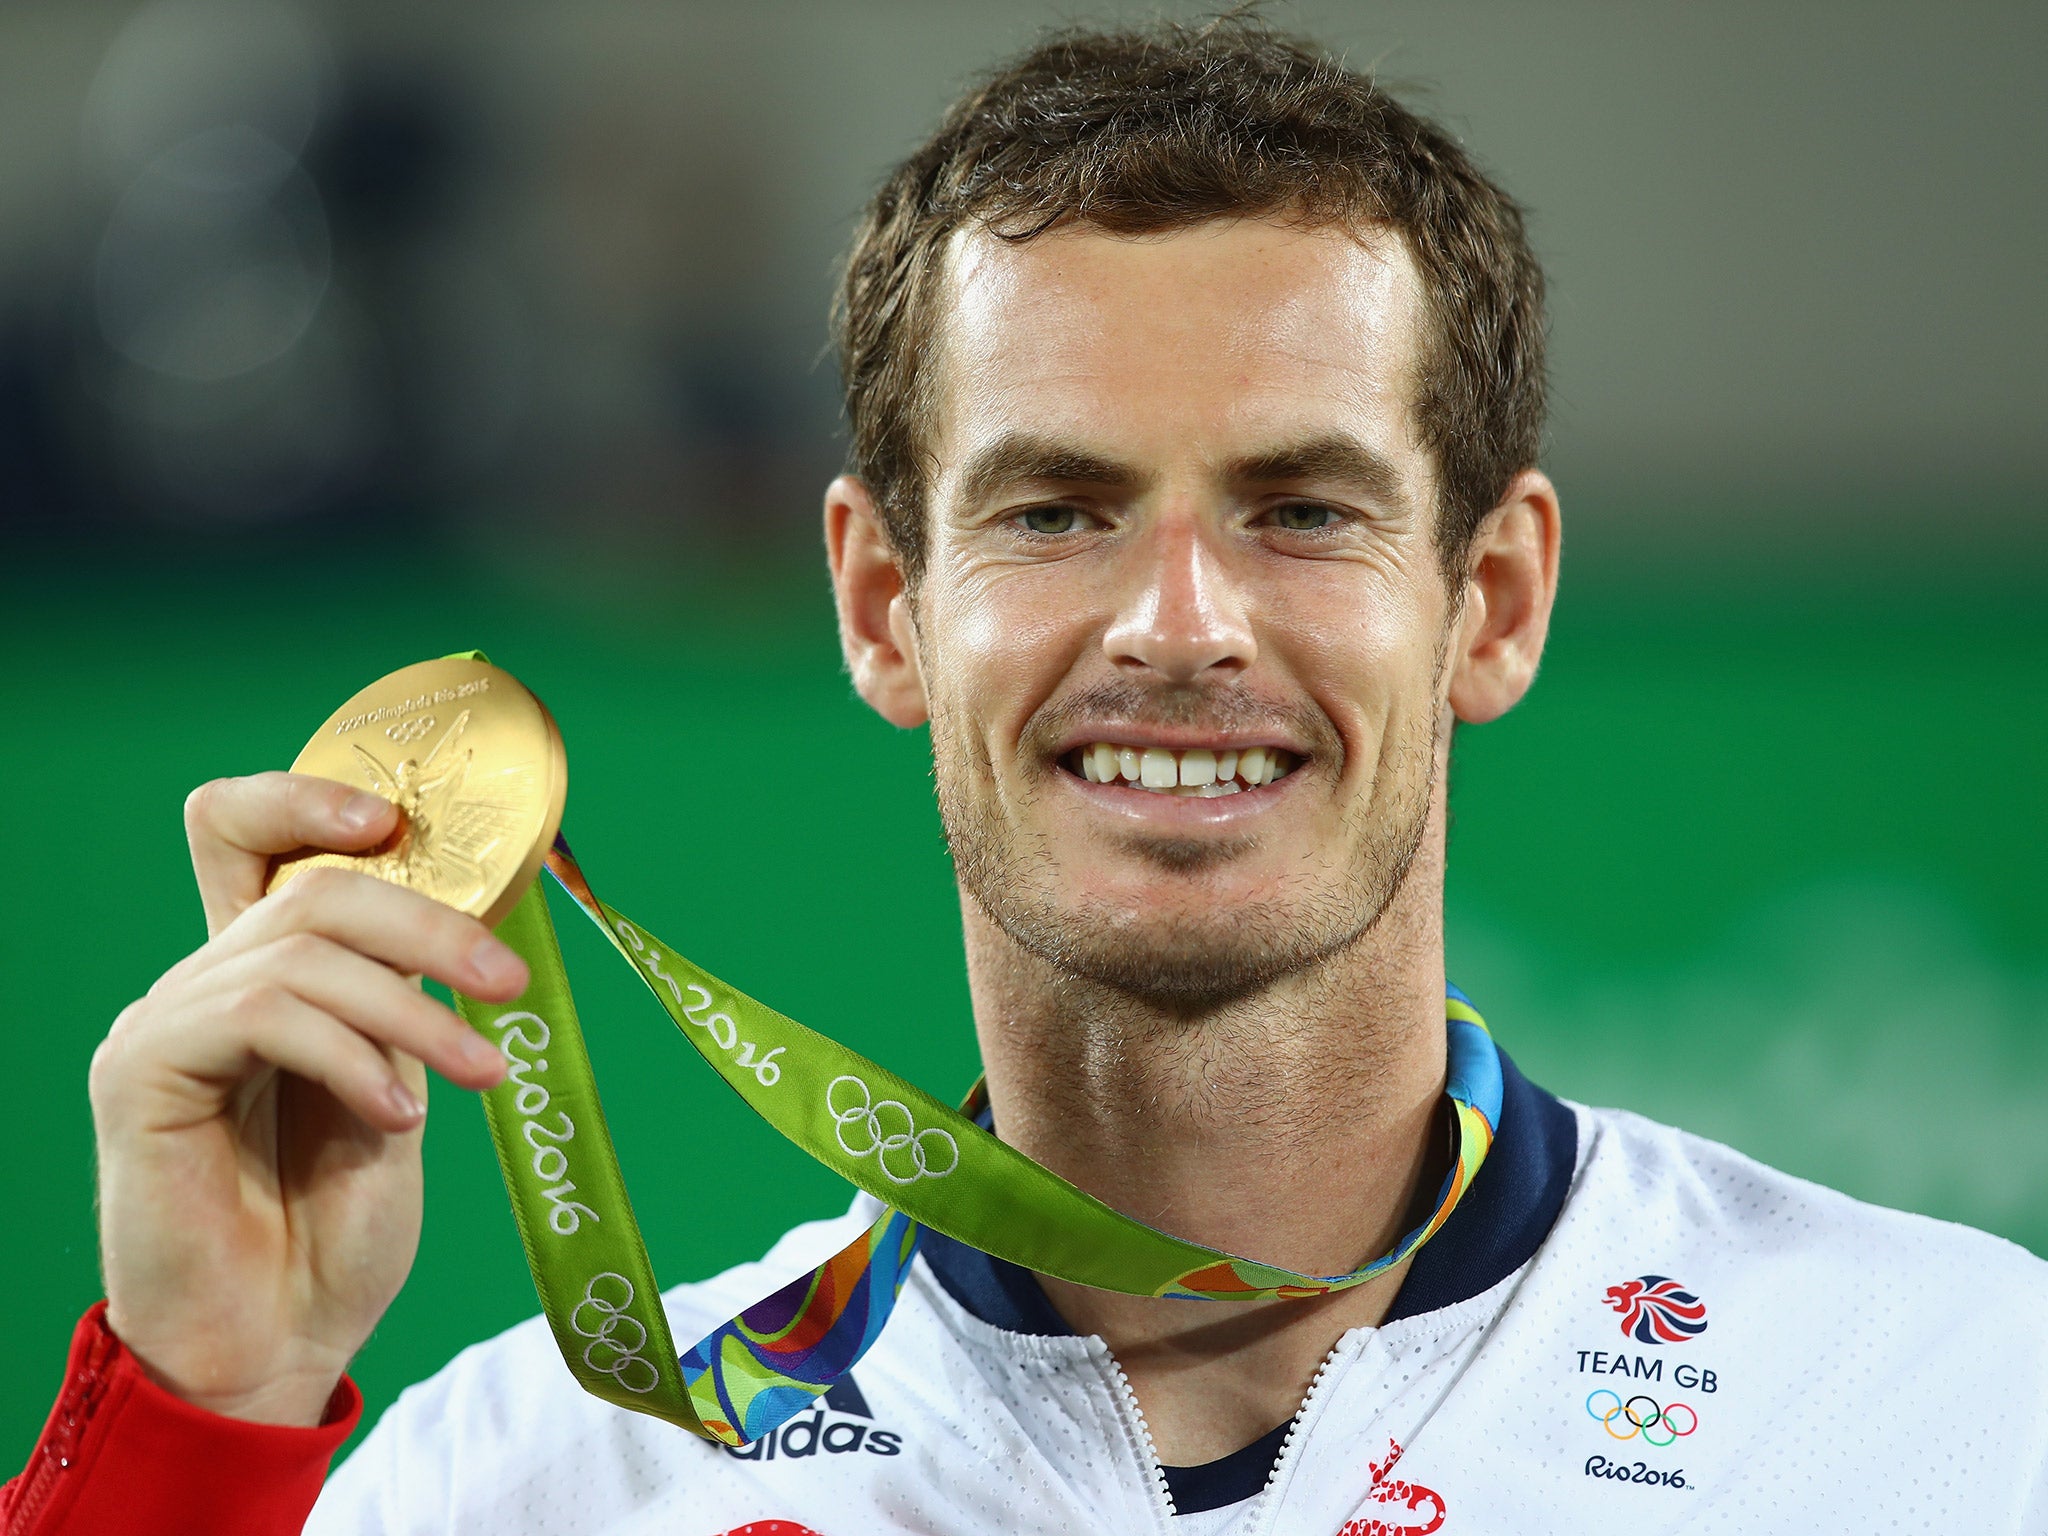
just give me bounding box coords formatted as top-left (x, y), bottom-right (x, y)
top-left (913, 221), bottom-right (1454, 1012)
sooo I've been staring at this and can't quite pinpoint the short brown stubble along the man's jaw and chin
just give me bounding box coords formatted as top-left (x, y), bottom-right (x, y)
top-left (932, 671), bottom-right (1442, 1018)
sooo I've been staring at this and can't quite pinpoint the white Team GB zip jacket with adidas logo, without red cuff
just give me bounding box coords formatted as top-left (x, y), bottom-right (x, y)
top-left (307, 1067), bottom-right (2048, 1536)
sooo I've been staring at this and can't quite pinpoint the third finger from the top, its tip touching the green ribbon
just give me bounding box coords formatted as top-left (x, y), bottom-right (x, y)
top-left (193, 934), bottom-right (506, 1090)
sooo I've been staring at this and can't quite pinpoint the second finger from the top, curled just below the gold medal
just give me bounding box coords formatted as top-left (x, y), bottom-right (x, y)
top-left (158, 868), bottom-right (526, 1001)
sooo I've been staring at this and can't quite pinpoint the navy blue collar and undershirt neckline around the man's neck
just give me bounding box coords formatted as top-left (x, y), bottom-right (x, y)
top-left (920, 1051), bottom-right (1579, 1516)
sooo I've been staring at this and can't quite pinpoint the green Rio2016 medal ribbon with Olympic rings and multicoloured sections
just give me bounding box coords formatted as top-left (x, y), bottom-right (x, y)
top-left (457, 842), bottom-right (1501, 1444)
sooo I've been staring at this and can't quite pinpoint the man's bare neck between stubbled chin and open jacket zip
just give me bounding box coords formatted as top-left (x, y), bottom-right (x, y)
top-left (963, 823), bottom-right (1446, 1462)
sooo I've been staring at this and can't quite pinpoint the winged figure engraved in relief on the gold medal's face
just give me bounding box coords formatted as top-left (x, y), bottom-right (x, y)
top-left (350, 709), bottom-right (526, 907)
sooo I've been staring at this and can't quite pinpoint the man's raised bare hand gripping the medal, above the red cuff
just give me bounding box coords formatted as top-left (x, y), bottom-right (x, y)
top-left (92, 774), bottom-right (526, 1423)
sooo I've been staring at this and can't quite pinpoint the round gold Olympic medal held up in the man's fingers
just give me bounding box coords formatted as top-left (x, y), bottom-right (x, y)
top-left (270, 657), bottom-right (569, 924)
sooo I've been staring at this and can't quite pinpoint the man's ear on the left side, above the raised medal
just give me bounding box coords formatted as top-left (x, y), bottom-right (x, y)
top-left (825, 475), bottom-right (930, 727)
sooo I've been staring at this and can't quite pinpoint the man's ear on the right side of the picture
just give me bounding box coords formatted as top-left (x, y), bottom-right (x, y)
top-left (1450, 469), bottom-right (1563, 725)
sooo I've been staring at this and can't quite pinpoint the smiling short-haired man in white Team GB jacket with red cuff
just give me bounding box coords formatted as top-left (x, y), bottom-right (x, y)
top-left (12, 20), bottom-right (2048, 1536)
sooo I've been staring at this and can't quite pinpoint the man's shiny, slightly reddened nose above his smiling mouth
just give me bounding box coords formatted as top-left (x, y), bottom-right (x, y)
top-left (1102, 508), bottom-right (1257, 684)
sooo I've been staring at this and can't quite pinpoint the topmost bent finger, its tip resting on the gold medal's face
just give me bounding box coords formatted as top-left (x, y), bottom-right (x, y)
top-left (184, 772), bottom-right (397, 934)
